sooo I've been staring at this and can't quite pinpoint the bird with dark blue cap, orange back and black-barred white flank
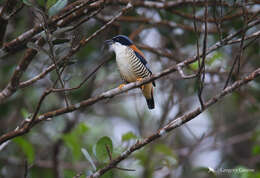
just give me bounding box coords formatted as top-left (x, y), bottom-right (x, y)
top-left (105, 35), bottom-right (155, 109)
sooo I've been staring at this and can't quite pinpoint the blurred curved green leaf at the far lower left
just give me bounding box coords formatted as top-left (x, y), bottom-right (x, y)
top-left (13, 137), bottom-right (35, 164)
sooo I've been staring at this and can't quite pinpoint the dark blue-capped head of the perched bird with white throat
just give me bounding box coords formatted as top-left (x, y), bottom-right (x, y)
top-left (105, 35), bottom-right (133, 49)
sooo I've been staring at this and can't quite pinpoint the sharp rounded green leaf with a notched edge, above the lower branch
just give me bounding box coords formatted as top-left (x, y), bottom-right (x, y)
top-left (95, 136), bottom-right (113, 162)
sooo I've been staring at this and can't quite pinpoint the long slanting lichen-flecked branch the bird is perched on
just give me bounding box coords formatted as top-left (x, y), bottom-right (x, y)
top-left (0, 26), bottom-right (260, 144)
